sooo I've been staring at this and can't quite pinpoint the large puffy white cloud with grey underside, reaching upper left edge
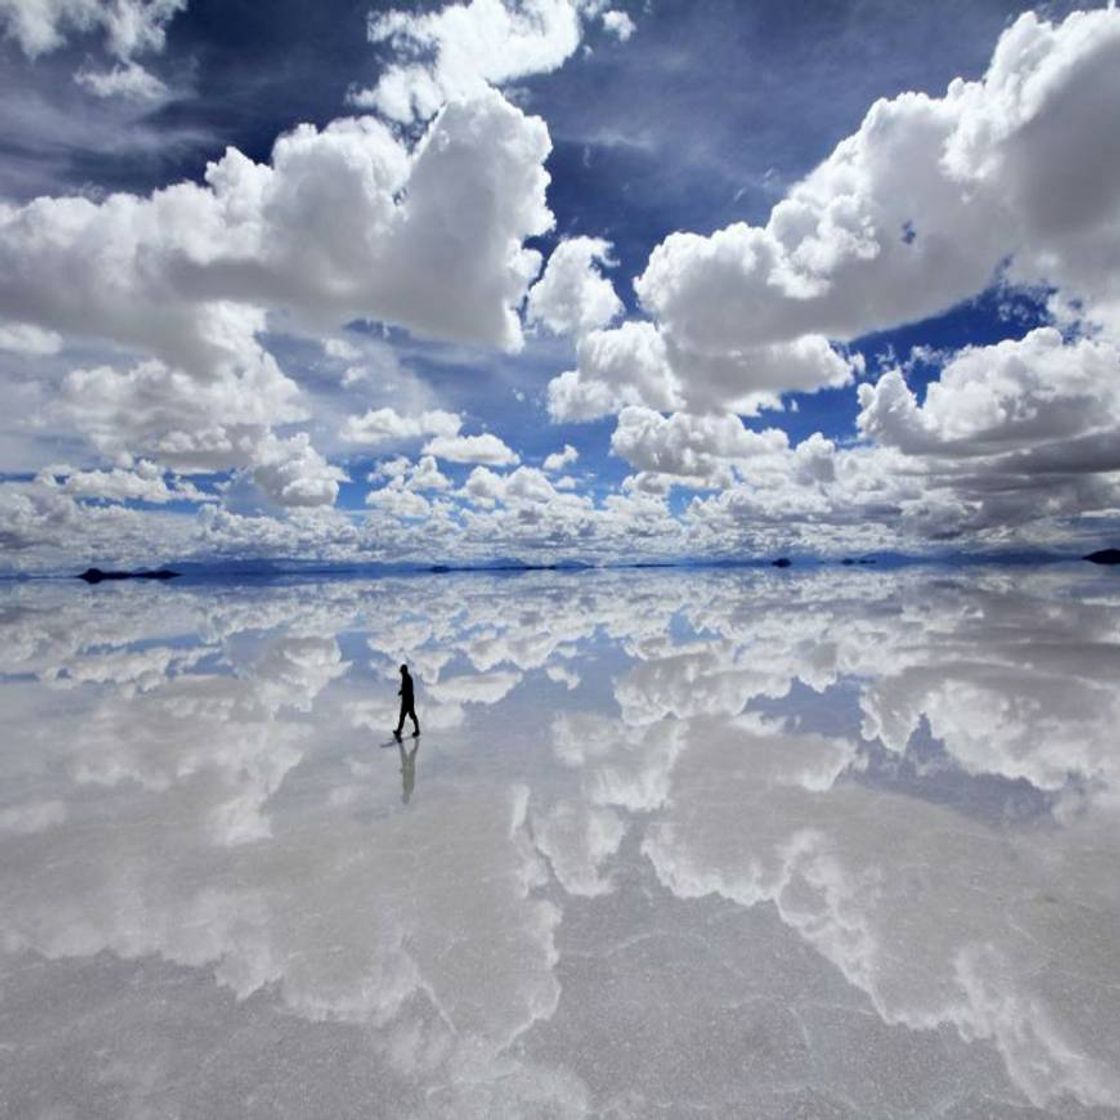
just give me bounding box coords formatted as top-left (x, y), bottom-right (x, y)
top-left (0, 93), bottom-right (552, 358)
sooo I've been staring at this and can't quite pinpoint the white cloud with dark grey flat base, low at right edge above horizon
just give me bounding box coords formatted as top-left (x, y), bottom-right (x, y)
top-left (842, 327), bottom-right (1120, 534)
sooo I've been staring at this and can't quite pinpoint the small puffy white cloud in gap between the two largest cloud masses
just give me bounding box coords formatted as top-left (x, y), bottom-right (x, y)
top-left (525, 237), bottom-right (625, 336)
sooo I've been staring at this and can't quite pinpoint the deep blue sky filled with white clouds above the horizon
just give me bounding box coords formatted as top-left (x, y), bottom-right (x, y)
top-left (0, 0), bottom-right (1120, 572)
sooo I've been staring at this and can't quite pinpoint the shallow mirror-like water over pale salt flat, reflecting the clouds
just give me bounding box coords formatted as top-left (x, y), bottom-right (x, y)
top-left (0, 567), bottom-right (1120, 1120)
